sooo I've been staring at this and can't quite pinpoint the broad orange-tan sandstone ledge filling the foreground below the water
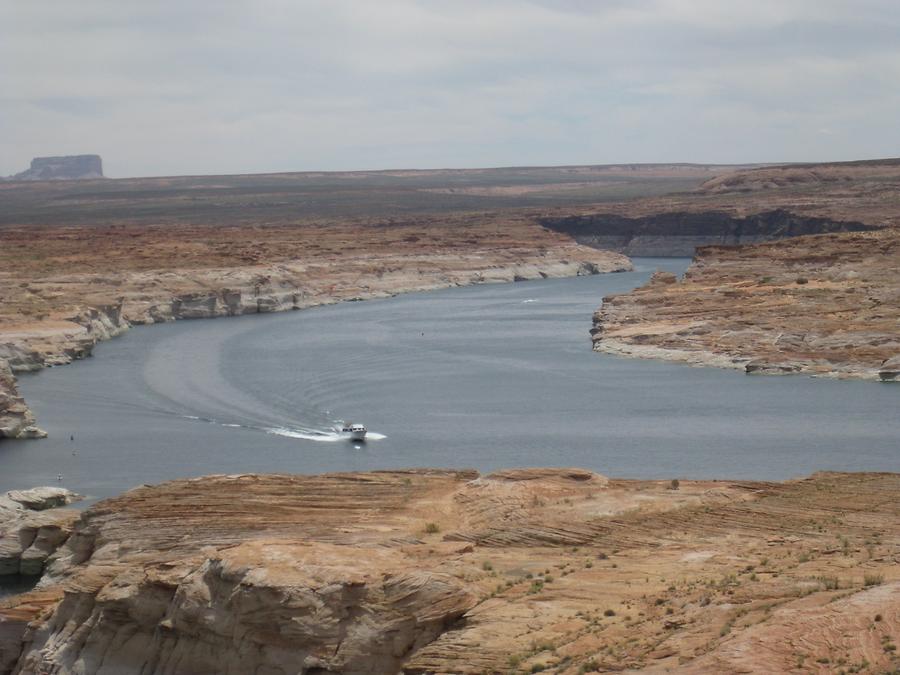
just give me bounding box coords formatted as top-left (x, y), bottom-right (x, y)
top-left (0, 469), bottom-right (900, 675)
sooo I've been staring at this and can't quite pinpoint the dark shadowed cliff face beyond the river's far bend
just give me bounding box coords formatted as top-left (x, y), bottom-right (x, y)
top-left (540, 209), bottom-right (877, 257)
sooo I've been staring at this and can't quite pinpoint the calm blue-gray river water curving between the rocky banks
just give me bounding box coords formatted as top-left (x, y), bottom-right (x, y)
top-left (0, 259), bottom-right (900, 508)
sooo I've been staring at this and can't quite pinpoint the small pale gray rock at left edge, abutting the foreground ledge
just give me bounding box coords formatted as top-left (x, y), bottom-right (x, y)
top-left (0, 487), bottom-right (80, 577)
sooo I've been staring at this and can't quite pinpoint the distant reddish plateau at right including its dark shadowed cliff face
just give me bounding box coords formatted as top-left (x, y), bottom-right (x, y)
top-left (537, 159), bottom-right (900, 256)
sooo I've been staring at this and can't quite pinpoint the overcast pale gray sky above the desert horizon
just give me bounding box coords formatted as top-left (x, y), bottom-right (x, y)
top-left (0, 0), bottom-right (900, 177)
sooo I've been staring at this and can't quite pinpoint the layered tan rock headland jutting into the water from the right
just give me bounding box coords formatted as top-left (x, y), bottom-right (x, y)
top-left (592, 228), bottom-right (900, 381)
